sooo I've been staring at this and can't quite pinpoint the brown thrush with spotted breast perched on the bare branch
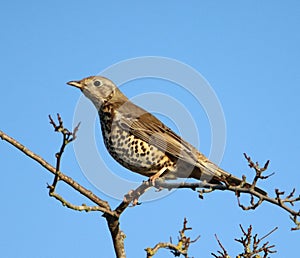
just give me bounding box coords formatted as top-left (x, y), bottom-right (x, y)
top-left (67, 76), bottom-right (266, 195)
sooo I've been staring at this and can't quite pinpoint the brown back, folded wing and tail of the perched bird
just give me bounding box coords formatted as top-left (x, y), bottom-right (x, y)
top-left (110, 102), bottom-right (266, 195)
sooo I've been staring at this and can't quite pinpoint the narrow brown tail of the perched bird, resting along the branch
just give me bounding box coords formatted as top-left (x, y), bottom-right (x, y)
top-left (191, 159), bottom-right (267, 195)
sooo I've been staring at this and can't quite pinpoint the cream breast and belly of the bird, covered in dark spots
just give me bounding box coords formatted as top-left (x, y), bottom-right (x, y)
top-left (98, 102), bottom-right (174, 176)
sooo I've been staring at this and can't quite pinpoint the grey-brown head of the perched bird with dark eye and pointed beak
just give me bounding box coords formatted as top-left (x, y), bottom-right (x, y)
top-left (67, 76), bottom-right (126, 110)
